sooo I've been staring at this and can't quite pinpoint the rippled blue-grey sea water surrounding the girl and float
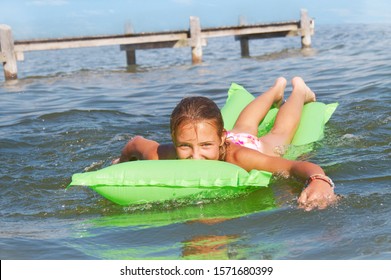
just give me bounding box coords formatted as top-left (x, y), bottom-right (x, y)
top-left (0, 25), bottom-right (391, 260)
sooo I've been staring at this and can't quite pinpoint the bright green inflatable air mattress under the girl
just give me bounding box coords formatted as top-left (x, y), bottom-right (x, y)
top-left (68, 83), bottom-right (338, 206)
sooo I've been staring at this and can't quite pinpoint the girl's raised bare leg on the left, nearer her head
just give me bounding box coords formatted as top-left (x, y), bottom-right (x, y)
top-left (232, 77), bottom-right (286, 136)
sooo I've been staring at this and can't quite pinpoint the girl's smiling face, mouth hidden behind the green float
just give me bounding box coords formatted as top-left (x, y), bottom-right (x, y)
top-left (173, 122), bottom-right (225, 160)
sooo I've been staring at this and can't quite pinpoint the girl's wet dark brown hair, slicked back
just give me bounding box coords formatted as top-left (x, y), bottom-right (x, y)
top-left (170, 96), bottom-right (226, 159)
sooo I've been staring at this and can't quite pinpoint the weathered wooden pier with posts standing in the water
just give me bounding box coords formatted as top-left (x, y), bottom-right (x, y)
top-left (0, 10), bottom-right (314, 80)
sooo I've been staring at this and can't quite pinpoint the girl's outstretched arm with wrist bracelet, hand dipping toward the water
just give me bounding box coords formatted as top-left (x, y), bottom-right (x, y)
top-left (227, 146), bottom-right (337, 210)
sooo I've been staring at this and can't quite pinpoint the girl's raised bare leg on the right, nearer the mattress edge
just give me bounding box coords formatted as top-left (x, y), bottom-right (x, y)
top-left (260, 77), bottom-right (316, 156)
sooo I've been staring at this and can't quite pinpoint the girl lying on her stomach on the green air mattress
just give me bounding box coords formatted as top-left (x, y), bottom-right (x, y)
top-left (113, 77), bottom-right (336, 210)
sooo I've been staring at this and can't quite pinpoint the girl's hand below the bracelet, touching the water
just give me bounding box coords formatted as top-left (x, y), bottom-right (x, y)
top-left (297, 180), bottom-right (338, 211)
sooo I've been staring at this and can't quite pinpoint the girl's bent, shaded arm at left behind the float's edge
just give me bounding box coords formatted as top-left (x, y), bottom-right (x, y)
top-left (113, 136), bottom-right (176, 163)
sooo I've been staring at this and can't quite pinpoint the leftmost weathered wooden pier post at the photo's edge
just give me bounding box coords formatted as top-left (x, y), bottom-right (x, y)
top-left (0, 24), bottom-right (18, 80)
